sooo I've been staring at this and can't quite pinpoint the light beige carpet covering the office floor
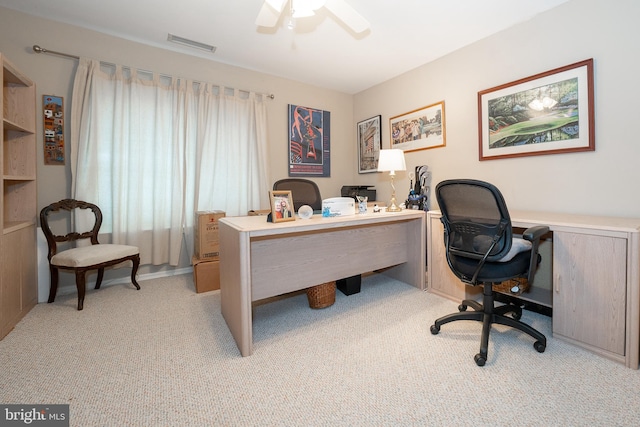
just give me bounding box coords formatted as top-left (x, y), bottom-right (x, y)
top-left (0, 275), bottom-right (640, 426)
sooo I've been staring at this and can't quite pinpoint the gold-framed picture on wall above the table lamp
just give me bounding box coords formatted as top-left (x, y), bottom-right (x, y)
top-left (389, 101), bottom-right (446, 152)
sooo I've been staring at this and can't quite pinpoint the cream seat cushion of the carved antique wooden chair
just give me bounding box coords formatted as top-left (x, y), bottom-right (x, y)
top-left (51, 244), bottom-right (140, 267)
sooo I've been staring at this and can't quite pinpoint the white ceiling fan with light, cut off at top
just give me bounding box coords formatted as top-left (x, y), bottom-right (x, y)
top-left (256, 0), bottom-right (369, 33)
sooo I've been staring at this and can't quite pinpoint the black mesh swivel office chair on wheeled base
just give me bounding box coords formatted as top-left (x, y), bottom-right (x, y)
top-left (431, 179), bottom-right (549, 366)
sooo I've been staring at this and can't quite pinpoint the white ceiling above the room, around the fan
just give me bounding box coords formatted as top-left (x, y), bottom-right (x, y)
top-left (0, 0), bottom-right (568, 94)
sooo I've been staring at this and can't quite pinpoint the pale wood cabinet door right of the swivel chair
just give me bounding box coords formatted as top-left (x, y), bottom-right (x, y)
top-left (553, 231), bottom-right (627, 356)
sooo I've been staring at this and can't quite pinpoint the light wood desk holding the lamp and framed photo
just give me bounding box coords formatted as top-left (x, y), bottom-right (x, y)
top-left (219, 210), bottom-right (426, 356)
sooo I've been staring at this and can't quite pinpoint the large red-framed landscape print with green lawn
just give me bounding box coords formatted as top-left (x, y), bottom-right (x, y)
top-left (478, 59), bottom-right (595, 160)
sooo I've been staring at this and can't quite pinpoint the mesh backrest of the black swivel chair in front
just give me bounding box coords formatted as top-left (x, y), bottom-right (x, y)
top-left (436, 179), bottom-right (513, 262)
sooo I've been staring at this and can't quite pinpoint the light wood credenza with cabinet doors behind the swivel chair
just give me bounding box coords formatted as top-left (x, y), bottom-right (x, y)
top-left (427, 210), bottom-right (640, 369)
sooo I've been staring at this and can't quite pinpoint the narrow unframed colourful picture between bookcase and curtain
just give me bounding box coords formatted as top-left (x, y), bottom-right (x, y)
top-left (42, 95), bottom-right (64, 165)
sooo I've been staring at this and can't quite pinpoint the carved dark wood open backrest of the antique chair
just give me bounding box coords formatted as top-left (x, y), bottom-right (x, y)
top-left (40, 199), bottom-right (102, 259)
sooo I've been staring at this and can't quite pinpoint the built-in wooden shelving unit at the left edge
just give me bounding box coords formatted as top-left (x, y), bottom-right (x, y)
top-left (0, 54), bottom-right (37, 339)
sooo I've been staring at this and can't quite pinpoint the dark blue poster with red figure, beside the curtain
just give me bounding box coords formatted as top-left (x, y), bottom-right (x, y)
top-left (289, 104), bottom-right (331, 177)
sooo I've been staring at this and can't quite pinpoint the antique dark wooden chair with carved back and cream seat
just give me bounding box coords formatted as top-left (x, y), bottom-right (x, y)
top-left (40, 199), bottom-right (140, 310)
